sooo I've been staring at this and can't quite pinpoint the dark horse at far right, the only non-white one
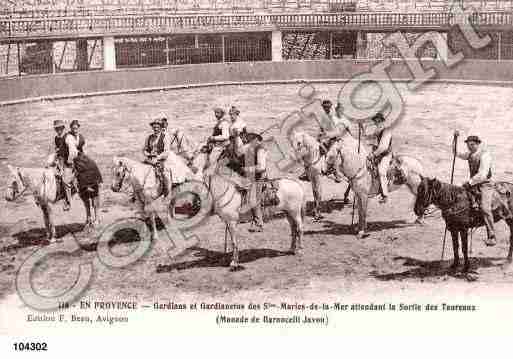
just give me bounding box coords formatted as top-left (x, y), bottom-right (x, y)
top-left (414, 177), bottom-right (513, 272)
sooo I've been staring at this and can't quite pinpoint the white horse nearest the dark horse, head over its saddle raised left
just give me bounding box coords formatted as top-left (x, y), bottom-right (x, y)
top-left (327, 134), bottom-right (424, 238)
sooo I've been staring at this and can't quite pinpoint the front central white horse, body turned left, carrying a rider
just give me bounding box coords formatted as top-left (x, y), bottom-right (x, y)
top-left (187, 153), bottom-right (306, 270)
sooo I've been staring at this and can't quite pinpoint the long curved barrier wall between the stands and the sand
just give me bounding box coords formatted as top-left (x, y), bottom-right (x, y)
top-left (0, 60), bottom-right (513, 105)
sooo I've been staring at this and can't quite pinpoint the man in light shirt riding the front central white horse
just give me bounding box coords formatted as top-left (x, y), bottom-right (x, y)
top-left (234, 129), bottom-right (267, 232)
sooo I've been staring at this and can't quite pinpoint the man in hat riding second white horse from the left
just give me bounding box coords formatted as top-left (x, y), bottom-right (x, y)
top-left (143, 119), bottom-right (171, 197)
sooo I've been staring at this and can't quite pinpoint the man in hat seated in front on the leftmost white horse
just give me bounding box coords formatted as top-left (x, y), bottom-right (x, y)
top-left (48, 120), bottom-right (74, 211)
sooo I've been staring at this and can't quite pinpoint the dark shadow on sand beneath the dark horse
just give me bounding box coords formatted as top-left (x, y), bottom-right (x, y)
top-left (370, 257), bottom-right (505, 281)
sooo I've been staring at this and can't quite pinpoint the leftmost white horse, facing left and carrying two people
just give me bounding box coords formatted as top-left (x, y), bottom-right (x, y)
top-left (5, 165), bottom-right (98, 243)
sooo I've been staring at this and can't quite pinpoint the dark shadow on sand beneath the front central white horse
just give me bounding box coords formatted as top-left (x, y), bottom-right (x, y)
top-left (157, 247), bottom-right (291, 273)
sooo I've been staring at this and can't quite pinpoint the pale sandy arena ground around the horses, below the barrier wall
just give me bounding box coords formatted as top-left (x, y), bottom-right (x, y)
top-left (0, 84), bottom-right (513, 306)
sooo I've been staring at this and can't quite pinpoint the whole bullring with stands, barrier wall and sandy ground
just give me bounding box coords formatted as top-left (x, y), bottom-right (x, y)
top-left (0, 0), bottom-right (513, 334)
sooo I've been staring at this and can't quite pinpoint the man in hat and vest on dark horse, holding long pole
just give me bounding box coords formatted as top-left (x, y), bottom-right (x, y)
top-left (454, 131), bottom-right (497, 246)
